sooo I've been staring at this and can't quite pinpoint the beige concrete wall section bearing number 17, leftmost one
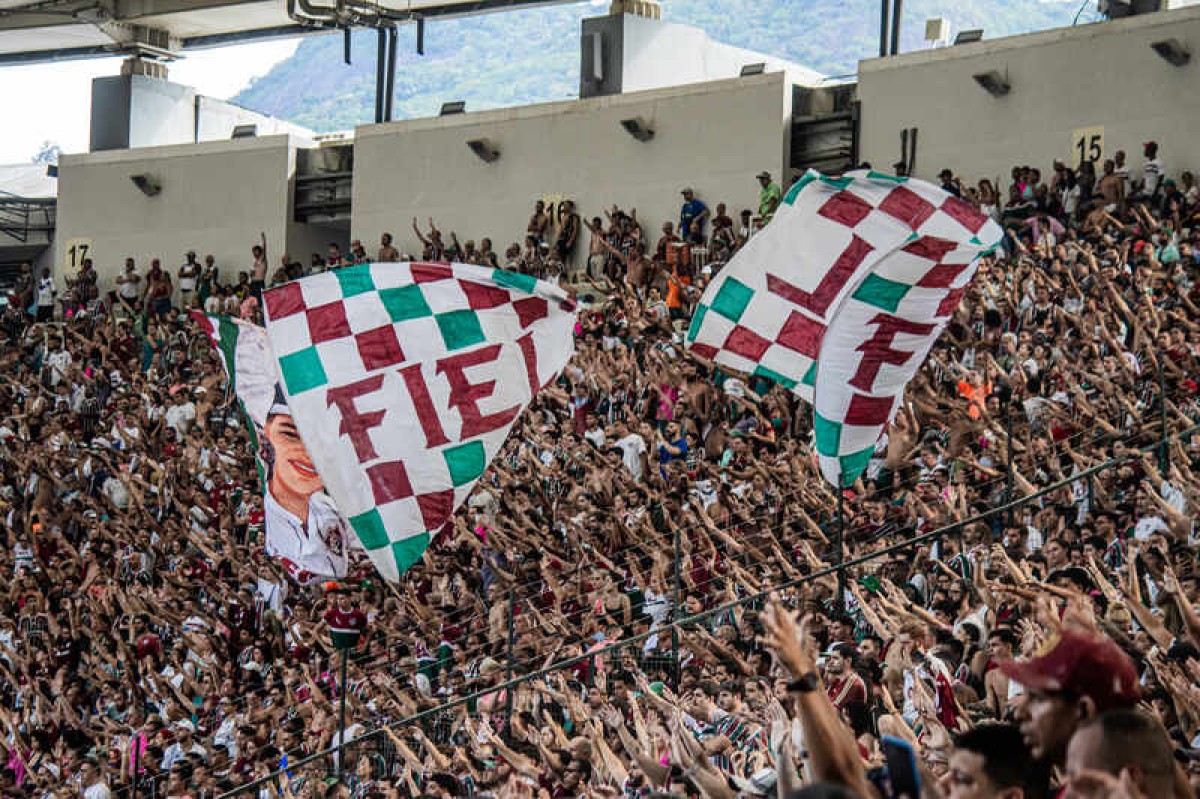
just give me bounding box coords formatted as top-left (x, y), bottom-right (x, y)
top-left (55, 136), bottom-right (294, 290)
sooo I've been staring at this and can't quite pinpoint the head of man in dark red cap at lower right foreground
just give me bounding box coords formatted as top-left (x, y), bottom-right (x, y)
top-left (997, 629), bottom-right (1140, 767)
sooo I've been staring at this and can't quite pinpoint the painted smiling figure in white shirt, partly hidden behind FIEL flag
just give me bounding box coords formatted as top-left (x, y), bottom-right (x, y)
top-left (260, 386), bottom-right (352, 583)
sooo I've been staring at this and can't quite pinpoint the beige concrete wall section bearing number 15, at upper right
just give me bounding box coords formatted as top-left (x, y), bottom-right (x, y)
top-left (858, 6), bottom-right (1200, 186)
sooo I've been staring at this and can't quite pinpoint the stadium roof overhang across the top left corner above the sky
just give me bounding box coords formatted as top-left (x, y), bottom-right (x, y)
top-left (0, 0), bottom-right (570, 66)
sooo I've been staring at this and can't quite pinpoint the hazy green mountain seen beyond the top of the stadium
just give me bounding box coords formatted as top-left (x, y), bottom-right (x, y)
top-left (233, 0), bottom-right (1094, 131)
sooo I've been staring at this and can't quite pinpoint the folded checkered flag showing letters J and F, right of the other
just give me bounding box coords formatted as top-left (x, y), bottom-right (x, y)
top-left (688, 170), bottom-right (1002, 486)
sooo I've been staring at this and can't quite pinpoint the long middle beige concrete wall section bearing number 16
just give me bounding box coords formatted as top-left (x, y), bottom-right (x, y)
top-left (352, 73), bottom-right (792, 263)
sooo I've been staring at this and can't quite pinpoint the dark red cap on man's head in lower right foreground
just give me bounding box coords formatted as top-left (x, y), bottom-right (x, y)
top-left (997, 630), bottom-right (1141, 711)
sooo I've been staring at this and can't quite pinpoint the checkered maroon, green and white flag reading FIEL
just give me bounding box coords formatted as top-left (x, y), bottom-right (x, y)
top-left (263, 263), bottom-right (575, 579)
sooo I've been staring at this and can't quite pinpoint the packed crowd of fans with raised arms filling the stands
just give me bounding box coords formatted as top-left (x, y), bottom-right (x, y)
top-left (7, 145), bottom-right (1200, 799)
